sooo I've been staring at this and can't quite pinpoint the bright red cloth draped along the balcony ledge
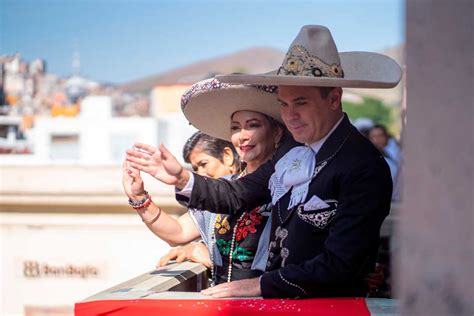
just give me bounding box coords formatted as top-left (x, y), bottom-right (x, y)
top-left (74, 298), bottom-right (370, 316)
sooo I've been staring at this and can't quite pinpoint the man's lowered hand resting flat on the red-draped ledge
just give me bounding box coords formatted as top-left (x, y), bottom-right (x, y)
top-left (201, 278), bottom-right (262, 298)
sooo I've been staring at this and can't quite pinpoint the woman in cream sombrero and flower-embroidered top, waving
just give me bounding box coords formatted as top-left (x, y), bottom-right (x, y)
top-left (123, 79), bottom-right (284, 284)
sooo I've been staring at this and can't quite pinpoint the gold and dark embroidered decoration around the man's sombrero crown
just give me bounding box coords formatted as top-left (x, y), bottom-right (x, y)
top-left (277, 45), bottom-right (344, 78)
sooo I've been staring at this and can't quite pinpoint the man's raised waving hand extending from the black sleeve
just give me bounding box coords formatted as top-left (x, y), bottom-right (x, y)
top-left (126, 143), bottom-right (189, 189)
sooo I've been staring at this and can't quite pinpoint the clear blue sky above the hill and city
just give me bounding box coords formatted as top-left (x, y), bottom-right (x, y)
top-left (0, 0), bottom-right (404, 83)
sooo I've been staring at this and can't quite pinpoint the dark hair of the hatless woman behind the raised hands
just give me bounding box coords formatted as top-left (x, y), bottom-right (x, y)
top-left (183, 132), bottom-right (240, 172)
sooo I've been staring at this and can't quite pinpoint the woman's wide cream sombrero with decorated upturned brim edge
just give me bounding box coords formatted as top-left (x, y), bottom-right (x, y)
top-left (181, 79), bottom-right (282, 140)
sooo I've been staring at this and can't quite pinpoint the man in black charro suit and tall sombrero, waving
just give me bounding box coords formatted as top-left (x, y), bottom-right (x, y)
top-left (127, 25), bottom-right (401, 298)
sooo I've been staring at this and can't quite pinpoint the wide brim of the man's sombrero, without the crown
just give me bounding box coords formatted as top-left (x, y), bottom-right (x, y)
top-left (216, 52), bottom-right (402, 88)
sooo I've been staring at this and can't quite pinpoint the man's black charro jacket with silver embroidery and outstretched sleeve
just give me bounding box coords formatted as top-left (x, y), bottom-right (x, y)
top-left (180, 116), bottom-right (392, 298)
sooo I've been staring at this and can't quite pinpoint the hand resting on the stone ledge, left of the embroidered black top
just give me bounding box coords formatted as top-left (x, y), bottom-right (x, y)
top-left (156, 242), bottom-right (211, 268)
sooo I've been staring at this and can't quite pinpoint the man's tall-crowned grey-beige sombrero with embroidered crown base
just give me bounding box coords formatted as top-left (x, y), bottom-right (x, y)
top-left (216, 25), bottom-right (402, 88)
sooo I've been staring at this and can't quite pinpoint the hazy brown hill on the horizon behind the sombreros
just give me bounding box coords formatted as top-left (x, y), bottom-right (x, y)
top-left (121, 45), bottom-right (404, 105)
